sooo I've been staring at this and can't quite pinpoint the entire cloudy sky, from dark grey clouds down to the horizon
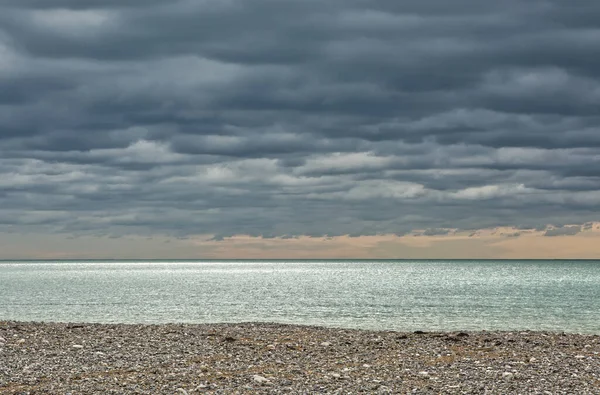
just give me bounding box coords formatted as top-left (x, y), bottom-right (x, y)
top-left (0, 0), bottom-right (600, 259)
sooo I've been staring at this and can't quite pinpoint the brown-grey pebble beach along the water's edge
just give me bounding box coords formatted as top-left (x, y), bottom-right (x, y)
top-left (0, 321), bottom-right (600, 394)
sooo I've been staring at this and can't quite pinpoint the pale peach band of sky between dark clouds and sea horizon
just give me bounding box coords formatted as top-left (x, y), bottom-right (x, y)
top-left (0, 223), bottom-right (600, 259)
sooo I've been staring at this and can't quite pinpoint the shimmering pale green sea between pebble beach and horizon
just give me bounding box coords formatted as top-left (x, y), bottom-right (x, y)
top-left (0, 261), bottom-right (600, 333)
